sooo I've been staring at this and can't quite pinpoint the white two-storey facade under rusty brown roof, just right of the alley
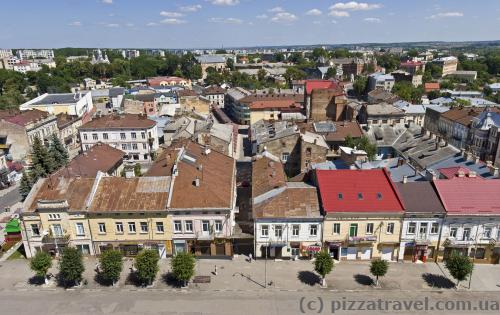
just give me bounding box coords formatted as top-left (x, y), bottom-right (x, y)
top-left (254, 218), bottom-right (323, 259)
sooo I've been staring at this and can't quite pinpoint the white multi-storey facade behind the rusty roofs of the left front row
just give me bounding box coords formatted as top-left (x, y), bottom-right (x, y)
top-left (79, 124), bottom-right (159, 162)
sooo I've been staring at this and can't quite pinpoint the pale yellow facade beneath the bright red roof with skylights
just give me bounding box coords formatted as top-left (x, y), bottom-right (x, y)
top-left (323, 215), bottom-right (402, 260)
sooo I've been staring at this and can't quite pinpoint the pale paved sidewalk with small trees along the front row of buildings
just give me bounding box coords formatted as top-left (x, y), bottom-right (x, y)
top-left (0, 256), bottom-right (500, 292)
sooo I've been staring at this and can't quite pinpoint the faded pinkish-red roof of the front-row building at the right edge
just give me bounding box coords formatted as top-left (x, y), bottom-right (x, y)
top-left (434, 177), bottom-right (500, 215)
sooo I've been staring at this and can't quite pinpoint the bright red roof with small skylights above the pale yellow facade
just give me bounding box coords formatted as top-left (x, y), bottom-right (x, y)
top-left (316, 169), bottom-right (404, 213)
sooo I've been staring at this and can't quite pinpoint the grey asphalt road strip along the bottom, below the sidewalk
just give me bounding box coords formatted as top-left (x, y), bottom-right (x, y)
top-left (0, 289), bottom-right (500, 315)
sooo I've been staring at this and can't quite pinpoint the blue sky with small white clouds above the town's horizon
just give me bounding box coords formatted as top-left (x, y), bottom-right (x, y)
top-left (0, 0), bottom-right (500, 49)
